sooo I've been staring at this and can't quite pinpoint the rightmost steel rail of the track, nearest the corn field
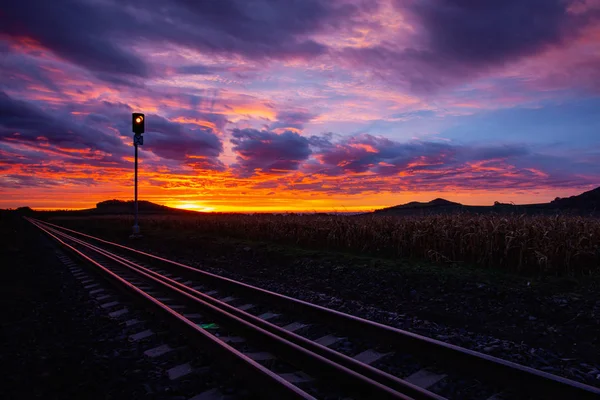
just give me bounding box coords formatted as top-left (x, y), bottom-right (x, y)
top-left (32, 221), bottom-right (600, 400)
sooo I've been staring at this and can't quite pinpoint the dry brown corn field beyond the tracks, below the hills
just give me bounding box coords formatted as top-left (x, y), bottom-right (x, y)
top-left (56, 214), bottom-right (600, 276)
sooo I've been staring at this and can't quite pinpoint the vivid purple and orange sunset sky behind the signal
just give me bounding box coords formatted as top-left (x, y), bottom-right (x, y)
top-left (0, 0), bottom-right (600, 211)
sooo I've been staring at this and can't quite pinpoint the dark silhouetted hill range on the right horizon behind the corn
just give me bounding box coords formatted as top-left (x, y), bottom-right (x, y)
top-left (373, 187), bottom-right (600, 215)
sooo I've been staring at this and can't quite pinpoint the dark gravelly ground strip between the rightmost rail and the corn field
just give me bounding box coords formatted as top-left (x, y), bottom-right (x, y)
top-left (54, 219), bottom-right (600, 386)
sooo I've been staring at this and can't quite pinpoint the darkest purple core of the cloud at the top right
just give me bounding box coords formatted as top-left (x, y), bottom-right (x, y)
top-left (406, 0), bottom-right (589, 64)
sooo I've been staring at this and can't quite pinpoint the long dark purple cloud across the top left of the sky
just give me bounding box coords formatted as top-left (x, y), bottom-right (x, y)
top-left (0, 0), bottom-right (370, 84)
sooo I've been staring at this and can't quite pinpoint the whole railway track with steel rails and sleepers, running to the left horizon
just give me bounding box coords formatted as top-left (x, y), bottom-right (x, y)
top-left (28, 219), bottom-right (600, 400)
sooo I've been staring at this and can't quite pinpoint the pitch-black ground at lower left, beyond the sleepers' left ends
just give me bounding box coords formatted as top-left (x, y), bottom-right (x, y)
top-left (0, 215), bottom-right (162, 400)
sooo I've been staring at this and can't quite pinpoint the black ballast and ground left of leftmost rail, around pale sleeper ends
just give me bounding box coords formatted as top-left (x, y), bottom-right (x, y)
top-left (0, 214), bottom-right (251, 400)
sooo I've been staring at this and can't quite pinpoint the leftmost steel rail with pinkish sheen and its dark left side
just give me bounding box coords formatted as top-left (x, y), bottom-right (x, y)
top-left (30, 220), bottom-right (315, 400)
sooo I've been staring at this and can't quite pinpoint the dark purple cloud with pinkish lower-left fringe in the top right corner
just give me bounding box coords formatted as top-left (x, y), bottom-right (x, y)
top-left (342, 0), bottom-right (600, 92)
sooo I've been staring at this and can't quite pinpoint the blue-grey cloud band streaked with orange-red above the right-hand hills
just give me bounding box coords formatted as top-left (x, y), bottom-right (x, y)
top-left (294, 135), bottom-right (600, 191)
